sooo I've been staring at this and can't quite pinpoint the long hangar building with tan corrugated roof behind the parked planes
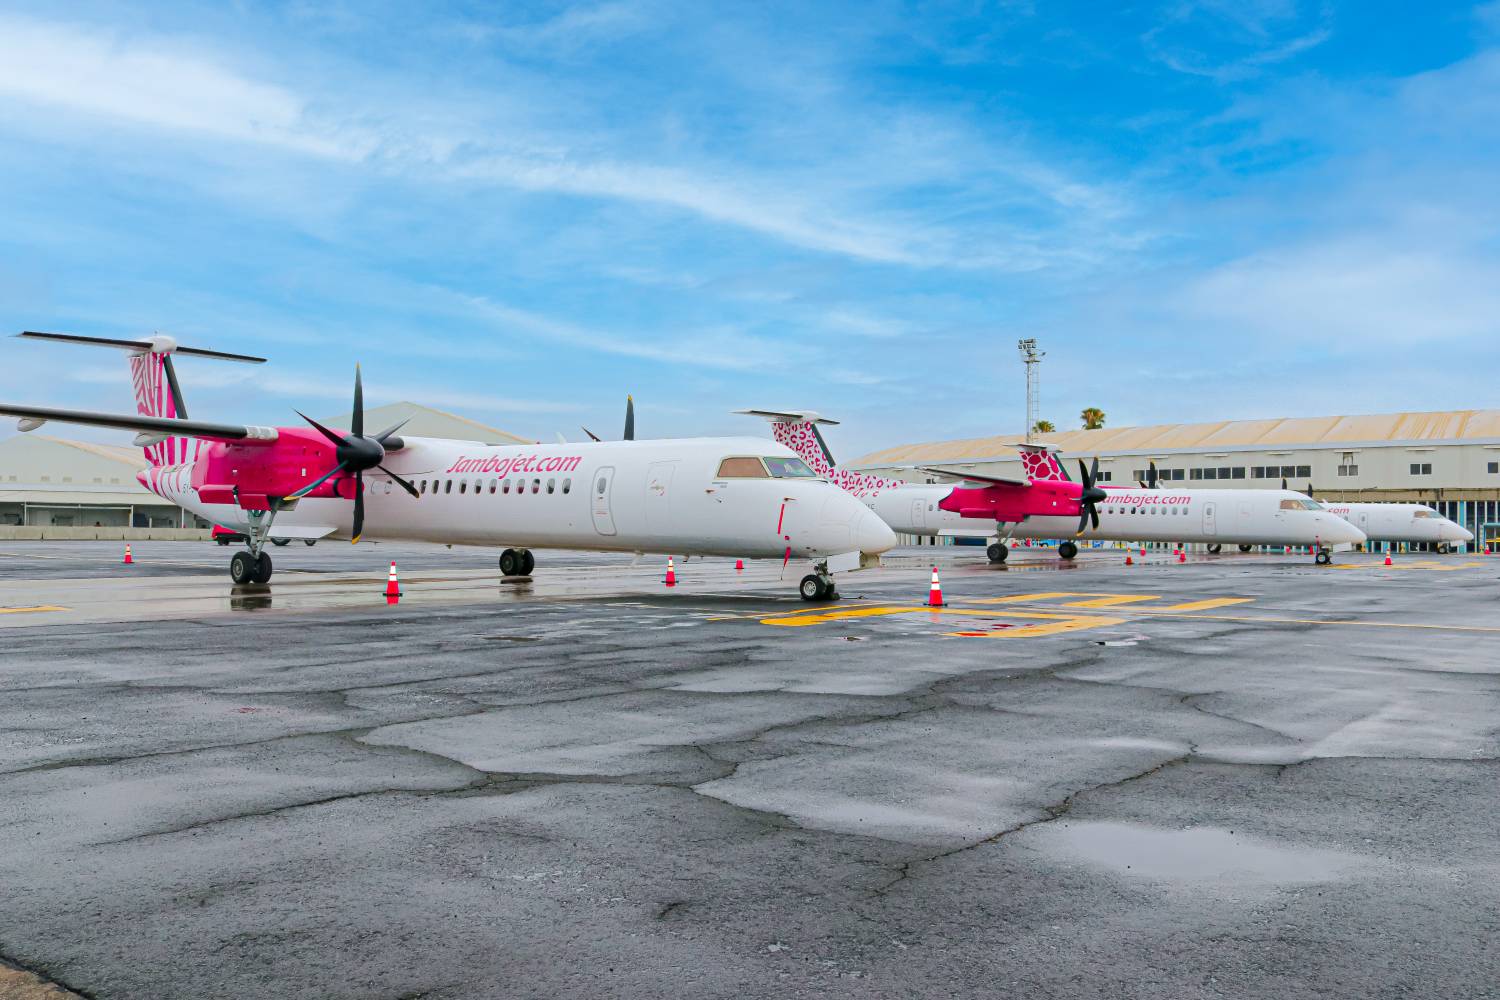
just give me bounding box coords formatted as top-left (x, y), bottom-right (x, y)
top-left (851, 409), bottom-right (1500, 547)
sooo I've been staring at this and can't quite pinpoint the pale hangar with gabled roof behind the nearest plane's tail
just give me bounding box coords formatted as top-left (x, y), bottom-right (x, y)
top-left (0, 403), bottom-right (531, 528)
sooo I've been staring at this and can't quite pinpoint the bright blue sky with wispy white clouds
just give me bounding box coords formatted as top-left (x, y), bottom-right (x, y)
top-left (0, 0), bottom-right (1500, 457)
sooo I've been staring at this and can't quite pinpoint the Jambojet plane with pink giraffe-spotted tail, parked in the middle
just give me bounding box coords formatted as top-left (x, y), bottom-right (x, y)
top-left (735, 409), bottom-right (1365, 564)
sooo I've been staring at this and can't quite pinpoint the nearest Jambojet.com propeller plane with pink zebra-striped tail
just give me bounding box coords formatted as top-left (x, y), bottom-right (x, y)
top-left (0, 331), bottom-right (896, 601)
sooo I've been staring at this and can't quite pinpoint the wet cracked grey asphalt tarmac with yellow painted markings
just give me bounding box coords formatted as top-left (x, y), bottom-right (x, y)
top-left (0, 543), bottom-right (1500, 999)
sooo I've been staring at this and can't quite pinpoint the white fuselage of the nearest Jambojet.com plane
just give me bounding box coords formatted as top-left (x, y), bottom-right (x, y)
top-left (141, 438), bottom-right (894, 559)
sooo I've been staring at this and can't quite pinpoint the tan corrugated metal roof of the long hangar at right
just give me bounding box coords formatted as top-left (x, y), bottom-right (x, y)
top-left (852, 409), bottom-right (1500, 466)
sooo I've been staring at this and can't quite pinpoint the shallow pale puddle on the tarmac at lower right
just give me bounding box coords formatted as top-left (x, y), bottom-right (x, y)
top-left (1037, 823), bottom-right (1361, 885)
